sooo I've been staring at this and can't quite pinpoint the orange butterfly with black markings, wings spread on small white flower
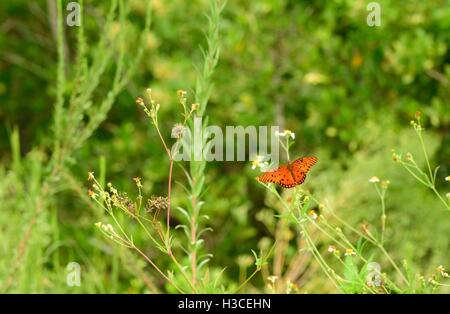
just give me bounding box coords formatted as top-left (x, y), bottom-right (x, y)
top-left (256, 157), bottom-right (317, 188)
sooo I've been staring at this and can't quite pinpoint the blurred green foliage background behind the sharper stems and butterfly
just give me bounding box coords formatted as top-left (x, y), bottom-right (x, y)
top-left (0, 0), bottom-right (450, 293)
